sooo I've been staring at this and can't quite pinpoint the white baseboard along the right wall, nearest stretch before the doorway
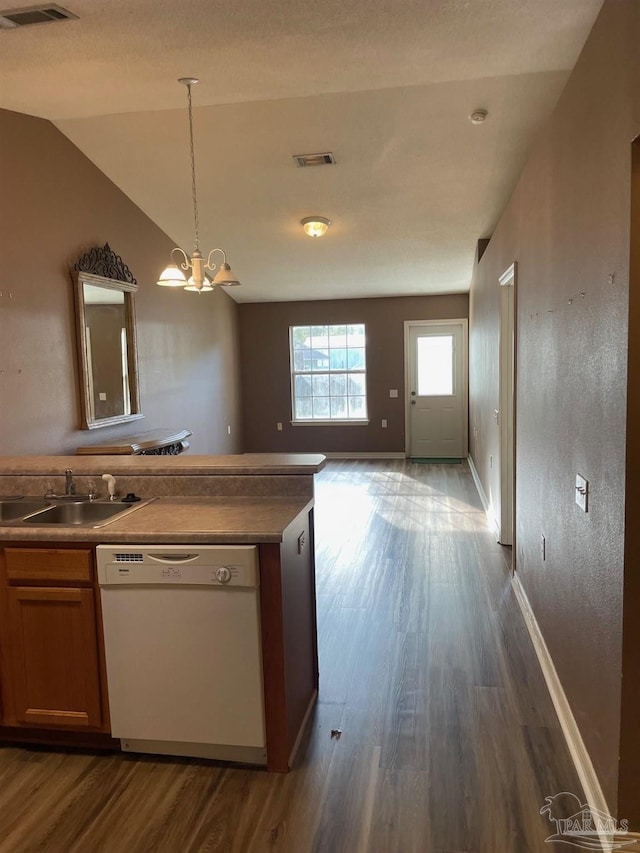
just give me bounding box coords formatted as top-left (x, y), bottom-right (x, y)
top-left (512, 575), bottom-right (616, 850)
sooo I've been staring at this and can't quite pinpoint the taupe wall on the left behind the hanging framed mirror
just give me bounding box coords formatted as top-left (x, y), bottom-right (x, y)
top-left (0, 110), bottom-right (241, 454)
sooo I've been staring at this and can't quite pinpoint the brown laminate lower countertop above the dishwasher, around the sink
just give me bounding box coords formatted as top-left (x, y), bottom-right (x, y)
top-left (0, 497), bottom-right (313, 544)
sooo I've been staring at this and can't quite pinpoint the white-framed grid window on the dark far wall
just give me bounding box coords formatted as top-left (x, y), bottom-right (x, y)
top-left (289, 323), bottom-right (367, 423)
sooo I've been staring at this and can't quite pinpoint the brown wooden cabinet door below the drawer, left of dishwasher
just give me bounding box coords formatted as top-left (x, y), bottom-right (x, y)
top-left (7, 587), bottom-right (101, 728)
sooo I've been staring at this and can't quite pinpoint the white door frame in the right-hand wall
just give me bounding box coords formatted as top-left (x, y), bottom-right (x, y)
top-left (496, 261), bottom-right (518, 548)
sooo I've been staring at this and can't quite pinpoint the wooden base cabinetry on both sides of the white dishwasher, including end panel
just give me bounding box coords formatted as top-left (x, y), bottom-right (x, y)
top-left (0, 505), bottom-right (318, 773)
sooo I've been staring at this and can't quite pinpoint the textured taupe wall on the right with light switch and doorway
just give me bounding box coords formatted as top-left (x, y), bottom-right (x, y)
top-left (470, 0), bottom-right (640, 827)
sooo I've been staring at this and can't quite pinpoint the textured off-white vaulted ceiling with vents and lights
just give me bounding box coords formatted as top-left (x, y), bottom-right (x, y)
top-left (0, 0), bottom-right (601, 302)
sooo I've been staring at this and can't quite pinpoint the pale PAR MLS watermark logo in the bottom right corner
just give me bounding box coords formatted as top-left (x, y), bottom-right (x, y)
top-left (540, 791), bottom-right (635, 851)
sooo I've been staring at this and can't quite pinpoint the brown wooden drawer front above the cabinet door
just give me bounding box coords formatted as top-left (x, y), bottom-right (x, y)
top-left (5, 548), bottom-right (93, 583)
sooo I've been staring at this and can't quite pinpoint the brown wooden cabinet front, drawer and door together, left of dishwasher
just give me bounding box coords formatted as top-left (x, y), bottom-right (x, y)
top-left (0, 547), bottom-right (105, 731)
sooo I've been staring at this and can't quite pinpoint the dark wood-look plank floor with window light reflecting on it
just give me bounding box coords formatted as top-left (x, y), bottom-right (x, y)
top-left (0, 461), bottom-right (582, 853)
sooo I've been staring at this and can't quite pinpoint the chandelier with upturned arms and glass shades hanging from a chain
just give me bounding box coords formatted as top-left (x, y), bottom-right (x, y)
top-left (157, 77), bottom-right (240, 293)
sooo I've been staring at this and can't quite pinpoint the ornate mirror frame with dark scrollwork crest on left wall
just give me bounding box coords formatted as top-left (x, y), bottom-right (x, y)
top-left (71, 243), bottom-right (144, 429)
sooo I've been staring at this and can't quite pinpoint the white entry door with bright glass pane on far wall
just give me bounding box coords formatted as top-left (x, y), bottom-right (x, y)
top-left (405, 320), bottom-right (467, 459)
